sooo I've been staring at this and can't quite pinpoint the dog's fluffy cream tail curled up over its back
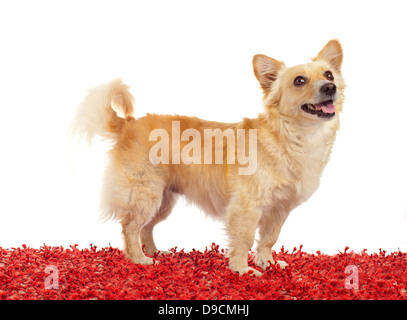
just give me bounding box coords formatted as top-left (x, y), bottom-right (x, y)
top-left (70, 79), bottom-right (134, 143)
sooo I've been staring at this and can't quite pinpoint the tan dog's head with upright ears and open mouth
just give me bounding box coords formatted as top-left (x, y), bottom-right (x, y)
top-left (253, 40), bottom-right (345, 121)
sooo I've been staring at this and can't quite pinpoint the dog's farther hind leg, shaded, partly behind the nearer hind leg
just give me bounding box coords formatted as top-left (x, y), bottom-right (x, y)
top-left (140, 190), bottom-right (178, 256)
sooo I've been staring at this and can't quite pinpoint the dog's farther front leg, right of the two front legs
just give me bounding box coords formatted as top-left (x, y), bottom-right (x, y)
top-left (254, 212), bottom-right (288, 269)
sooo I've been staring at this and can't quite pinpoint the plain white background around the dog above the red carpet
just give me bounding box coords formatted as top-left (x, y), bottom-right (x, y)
top-left (0, 0), bottom-right (407, 254)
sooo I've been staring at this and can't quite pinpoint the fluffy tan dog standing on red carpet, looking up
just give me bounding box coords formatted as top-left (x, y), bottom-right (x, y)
top-left (72, 40), bottom-right (345, 275)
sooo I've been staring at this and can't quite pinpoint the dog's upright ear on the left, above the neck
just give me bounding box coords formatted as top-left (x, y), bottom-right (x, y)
top-left (253, 54), bottom-right (284, 93)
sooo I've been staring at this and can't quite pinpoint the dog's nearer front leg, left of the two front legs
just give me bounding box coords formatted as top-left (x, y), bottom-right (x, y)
top-left (227, 196), bottom-right (261, 276)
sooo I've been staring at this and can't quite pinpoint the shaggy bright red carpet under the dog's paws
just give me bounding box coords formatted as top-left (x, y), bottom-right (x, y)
top-left (0, 244), bottom-right (407, 300)
